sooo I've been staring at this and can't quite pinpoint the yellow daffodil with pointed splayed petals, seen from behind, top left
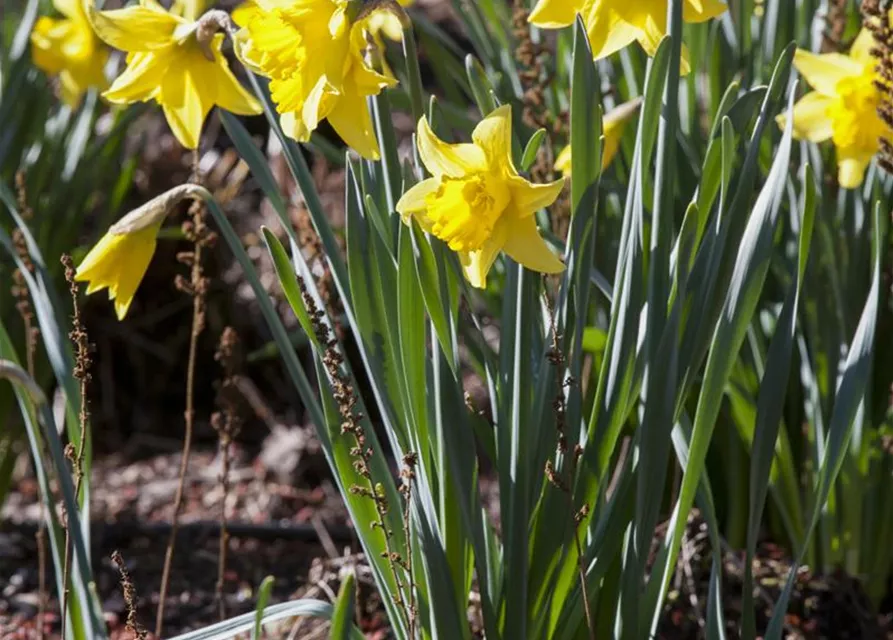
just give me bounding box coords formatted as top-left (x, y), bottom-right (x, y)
top-left (84, 0), bottom-right (261, 149)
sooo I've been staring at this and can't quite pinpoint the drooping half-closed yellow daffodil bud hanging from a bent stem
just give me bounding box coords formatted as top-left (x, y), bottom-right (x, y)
top-left (75, 218), bottom-right (164, 320)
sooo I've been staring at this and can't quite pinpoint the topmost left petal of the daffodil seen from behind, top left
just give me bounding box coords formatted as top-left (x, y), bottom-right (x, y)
top-left (83, 0), bottom-right (182, 51)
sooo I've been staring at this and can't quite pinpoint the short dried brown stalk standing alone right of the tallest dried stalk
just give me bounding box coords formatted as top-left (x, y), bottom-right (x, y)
top-left (211, 327), bottom-right (242, 620)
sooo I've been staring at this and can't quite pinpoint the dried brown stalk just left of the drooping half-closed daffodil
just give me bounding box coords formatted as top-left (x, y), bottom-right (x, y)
top-left (62, 255), bottom-right (90, 638)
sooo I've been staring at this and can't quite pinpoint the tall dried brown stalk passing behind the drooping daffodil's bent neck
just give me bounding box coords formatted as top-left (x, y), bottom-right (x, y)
top-left (155, 151), bottom-right (216, 638)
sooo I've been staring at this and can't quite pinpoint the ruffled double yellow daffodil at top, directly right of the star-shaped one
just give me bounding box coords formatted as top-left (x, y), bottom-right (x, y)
top-left (237, 0), bottom-right (397, 159)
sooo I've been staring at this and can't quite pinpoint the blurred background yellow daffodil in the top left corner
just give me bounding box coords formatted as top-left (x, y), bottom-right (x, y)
top-left (31, 0), bottom-right (109, 107)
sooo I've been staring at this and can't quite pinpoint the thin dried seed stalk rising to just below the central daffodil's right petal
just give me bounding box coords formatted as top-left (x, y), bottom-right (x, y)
top-left (543, 292), bottom-right (595, 640)
